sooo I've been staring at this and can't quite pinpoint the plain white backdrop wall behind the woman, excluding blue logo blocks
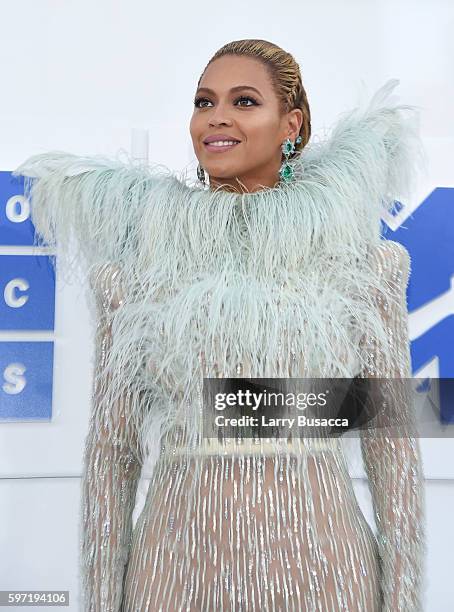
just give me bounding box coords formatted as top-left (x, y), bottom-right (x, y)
top-left (0, 0), bottom-right (454, 612)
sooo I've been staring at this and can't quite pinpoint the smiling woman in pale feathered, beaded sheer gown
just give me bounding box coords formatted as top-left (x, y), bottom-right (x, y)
top-left (16, 40), bottom-right (425, 612)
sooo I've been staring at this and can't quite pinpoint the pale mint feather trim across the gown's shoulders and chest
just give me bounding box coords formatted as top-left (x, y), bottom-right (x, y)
top-left (14, 80), bottom-right (423, 478)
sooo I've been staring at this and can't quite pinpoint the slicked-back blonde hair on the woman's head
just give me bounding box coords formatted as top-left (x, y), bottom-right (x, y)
top-left (197, 38), bottom-right (311, 157)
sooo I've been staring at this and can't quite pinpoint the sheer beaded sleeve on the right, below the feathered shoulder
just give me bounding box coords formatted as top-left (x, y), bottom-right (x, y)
top-left (361, 241), bottom-right (426, 612)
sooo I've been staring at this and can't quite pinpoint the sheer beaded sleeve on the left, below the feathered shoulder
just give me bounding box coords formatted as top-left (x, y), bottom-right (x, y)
top-left (80, 265), bottom-right (145, 612)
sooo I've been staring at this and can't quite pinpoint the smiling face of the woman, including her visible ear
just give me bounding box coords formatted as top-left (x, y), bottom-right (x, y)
top-left (190, 55), bottom-right (302, 192)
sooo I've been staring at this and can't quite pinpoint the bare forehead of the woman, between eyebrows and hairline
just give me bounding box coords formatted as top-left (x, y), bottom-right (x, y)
top-left (199, 55), bottom-right (271, 94)
